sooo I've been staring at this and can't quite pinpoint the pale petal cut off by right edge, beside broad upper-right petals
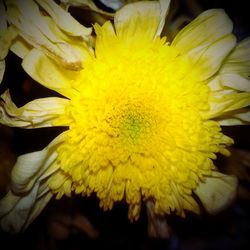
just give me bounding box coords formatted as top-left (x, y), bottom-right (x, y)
top-left (220, 37), bottom-right (250, 77)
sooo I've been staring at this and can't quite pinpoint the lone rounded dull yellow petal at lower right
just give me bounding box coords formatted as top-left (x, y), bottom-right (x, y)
top-left (194, 172), bottom-right (238, 214)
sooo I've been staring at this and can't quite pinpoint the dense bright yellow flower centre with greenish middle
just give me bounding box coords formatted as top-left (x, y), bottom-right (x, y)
top-left (52, 30), bottom-right (231, 217)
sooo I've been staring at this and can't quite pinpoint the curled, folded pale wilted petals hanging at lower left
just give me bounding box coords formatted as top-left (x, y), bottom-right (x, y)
top-left (0, 133), bottom-right (65, 232)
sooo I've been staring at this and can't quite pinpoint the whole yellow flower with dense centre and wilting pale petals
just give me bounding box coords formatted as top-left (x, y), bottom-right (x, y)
top-left (0, 0), bottom-right (250, 231)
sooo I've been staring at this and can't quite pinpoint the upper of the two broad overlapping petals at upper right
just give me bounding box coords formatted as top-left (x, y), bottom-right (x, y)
top-left (172, 9), bottom-right (233, 54)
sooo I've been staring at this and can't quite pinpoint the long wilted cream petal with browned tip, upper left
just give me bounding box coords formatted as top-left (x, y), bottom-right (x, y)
top-left (7, 0), bottom-right (92, 70)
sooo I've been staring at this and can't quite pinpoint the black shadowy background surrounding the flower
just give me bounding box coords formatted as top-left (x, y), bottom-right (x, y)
top-left (0, 0), bottom-right (250, 250)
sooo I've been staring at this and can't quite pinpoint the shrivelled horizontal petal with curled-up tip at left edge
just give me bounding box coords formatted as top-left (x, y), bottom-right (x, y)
top-left (0, 90), bottom-right (69, 128)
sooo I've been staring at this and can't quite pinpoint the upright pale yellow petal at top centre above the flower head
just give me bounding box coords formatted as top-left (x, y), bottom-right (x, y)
top-left (114, 1), bottom-right (161, 40)
